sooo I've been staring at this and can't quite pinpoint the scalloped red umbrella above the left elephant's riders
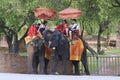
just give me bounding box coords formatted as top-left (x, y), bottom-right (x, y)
top-left (33, 8), bottom-right (56, 19)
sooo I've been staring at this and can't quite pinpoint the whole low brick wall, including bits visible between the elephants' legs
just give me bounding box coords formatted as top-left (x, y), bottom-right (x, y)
top-left (0, 53), bottom-right (72, 74)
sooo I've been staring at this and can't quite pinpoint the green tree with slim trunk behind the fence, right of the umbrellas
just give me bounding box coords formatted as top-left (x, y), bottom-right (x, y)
top-left (78, 0), bottom-right (120, 53)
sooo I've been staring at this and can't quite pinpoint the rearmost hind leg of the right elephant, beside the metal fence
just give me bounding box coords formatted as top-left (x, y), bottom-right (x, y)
top-left (81, 51), bottom-right (90, 75)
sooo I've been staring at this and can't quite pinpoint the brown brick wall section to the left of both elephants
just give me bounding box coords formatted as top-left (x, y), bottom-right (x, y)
top-left (0, 54), bottom-right (27, 73)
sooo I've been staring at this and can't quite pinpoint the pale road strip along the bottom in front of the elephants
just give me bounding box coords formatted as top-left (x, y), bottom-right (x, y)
top-left (0, 73), bottom-right (120, 80)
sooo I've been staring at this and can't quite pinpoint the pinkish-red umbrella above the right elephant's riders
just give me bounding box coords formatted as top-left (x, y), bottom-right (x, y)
top-left (59, 8), bottom-right (81, 19)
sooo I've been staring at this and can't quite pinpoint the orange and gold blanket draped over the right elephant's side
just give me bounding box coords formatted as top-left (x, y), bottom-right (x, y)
top-left (70, 39), bottom-right (84, 61)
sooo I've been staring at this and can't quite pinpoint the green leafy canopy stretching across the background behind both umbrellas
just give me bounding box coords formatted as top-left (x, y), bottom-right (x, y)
top-left (0, 0), bottom-right (120, 53)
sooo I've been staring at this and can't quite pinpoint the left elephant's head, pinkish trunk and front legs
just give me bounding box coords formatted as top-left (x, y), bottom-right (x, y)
top-left (27, 38), bottom-right (45, 74)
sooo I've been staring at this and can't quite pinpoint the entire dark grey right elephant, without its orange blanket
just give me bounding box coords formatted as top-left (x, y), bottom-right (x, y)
top-left (44, 31), bottom-right (90, 75)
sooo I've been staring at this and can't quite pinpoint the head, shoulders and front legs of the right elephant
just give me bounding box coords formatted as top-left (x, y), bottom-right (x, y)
top-left (49, 31), bottom-right (69, 75)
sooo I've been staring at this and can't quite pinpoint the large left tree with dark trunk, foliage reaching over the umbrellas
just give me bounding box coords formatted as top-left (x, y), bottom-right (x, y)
top-left (0, 0), bottom-right (71, 53)
